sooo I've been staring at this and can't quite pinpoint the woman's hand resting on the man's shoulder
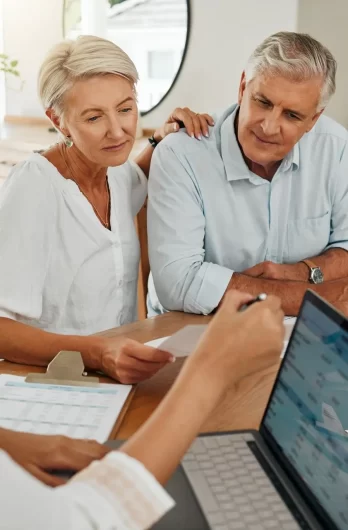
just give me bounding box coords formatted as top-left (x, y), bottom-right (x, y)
top-left (153, 107), bottom-right (214, 142)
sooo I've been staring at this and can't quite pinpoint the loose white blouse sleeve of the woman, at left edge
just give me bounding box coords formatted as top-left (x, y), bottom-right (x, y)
top-left (0, 161), bottom-right (56, 319)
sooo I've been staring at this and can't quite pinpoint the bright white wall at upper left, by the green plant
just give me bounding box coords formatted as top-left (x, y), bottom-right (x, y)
top-left (2, 0), bottom-right (63, 116)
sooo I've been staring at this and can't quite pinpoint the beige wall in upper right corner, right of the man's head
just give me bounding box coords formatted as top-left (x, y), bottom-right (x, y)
top-left (298, 0), bottom-right (348, 127)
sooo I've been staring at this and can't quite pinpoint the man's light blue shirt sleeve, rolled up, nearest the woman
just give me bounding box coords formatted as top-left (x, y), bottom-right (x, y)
top-left (148, 139), bottom-right (233, 314)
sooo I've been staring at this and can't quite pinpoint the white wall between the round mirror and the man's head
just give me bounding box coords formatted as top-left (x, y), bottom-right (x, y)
top-left (143, 0), bottom-right (298, 127)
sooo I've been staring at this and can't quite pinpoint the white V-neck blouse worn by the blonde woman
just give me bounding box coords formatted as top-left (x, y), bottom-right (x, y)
top-left (0, 153), bottom-right (147, 335)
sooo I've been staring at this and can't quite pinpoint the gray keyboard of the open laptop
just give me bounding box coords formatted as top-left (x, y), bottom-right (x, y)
top-left (182, 433), bottom-right (300, 530)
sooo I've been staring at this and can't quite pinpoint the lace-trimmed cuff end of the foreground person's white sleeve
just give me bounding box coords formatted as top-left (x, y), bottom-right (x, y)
top-left (60, 451), bottom-right (174, 530)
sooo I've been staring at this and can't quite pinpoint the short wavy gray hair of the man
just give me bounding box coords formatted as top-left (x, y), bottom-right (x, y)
top-left (245, 31), bottom-right (337, 110)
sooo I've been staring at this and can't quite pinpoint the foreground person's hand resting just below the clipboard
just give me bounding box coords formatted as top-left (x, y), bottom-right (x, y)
top-left (0, 429), bottom-right (110, 486)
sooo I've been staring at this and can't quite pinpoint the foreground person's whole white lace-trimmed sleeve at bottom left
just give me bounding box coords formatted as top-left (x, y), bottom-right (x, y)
top-left (0, 451), bottom-right (174, 530)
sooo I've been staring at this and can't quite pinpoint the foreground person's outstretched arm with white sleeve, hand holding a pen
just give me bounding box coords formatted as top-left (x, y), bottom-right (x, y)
top-left (0, 293), bottom-right (284, 530)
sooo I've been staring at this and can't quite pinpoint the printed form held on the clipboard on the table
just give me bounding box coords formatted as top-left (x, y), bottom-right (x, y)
top-left (0, 374), bottom-right (132, 443)
